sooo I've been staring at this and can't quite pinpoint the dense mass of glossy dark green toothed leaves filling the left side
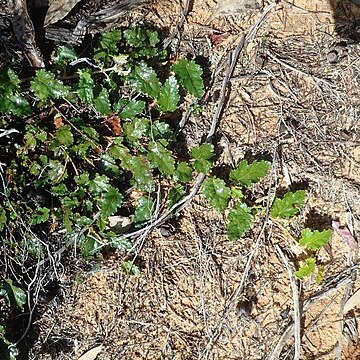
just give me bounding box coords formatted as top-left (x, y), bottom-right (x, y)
top-left (0, 27), bottom-right (208, 359)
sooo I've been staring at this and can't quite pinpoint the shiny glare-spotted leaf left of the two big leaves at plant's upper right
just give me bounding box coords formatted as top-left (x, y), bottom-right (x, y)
top-left (128, 61), bottom-right (161, 99)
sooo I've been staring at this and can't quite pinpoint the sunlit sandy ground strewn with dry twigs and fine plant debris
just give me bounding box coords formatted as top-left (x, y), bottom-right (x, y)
top-left (2, 0), bottom-right (360, 360)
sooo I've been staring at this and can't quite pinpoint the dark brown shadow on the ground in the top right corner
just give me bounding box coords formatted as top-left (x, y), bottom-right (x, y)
top-left (329, 0), bottom-right (360, 42)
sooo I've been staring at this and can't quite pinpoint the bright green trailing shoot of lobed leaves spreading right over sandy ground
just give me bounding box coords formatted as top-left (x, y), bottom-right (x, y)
top-left (202, 165), bottom-right (331, 281)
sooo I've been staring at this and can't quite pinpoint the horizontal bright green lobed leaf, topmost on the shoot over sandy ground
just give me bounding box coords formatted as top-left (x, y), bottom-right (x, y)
top-left (230, 160), bottom-right (270, 186)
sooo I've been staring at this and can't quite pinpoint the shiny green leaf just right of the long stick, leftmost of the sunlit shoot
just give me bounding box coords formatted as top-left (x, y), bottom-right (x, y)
top-left (202, 177), bottom-right (231, 212)
